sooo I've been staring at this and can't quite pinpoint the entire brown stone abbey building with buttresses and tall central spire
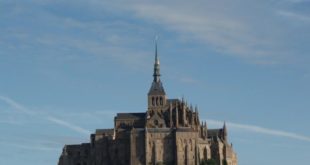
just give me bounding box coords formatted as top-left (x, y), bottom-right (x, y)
top-left (58, 45), bottom-right (237, 165)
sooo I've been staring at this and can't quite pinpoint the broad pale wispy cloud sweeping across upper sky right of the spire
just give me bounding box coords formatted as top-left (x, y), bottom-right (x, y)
top-left (94, 0), bottom-right (308, 65)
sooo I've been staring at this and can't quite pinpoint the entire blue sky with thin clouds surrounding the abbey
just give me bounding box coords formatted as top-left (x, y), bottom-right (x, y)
top-left (0, 0), bottom-right (310, 165)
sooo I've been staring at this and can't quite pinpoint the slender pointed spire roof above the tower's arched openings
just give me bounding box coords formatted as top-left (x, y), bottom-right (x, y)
top-left (149, 39), bottom-right (166, 95)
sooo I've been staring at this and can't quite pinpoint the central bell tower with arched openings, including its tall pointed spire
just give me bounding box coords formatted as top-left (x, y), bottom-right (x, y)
top-left (148, 40), bottom-right (167, 110)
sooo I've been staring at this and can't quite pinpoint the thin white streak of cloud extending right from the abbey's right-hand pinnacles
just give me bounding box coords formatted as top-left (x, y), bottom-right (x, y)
top-left (207, 119), bottom-right (310, 142)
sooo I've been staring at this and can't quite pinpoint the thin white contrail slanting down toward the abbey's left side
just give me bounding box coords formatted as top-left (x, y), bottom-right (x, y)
top-left (0, 95), bottom-right (91, 135)
